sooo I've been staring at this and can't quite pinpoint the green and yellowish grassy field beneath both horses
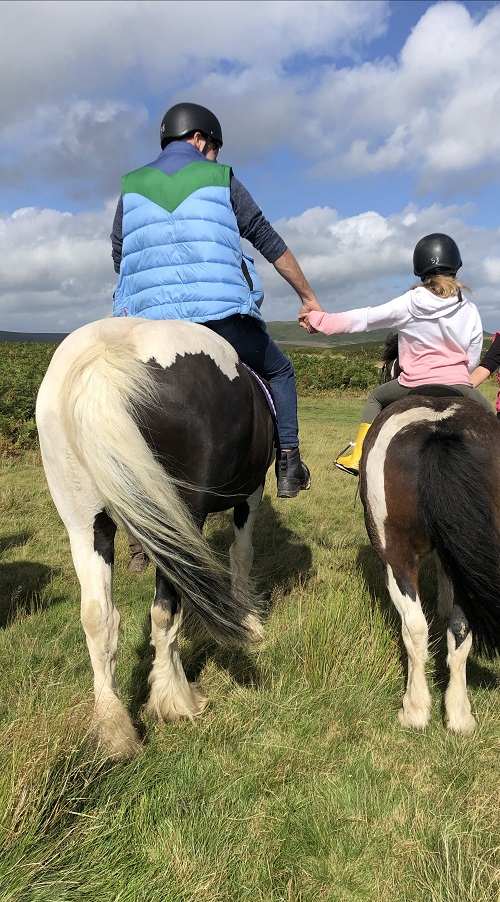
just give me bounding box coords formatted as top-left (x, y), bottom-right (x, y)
top-left (0, 390), bottom-right (500, 902)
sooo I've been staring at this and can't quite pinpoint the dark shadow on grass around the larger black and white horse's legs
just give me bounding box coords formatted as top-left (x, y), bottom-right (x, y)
top-left (130, 497), bottom-right (312, 718)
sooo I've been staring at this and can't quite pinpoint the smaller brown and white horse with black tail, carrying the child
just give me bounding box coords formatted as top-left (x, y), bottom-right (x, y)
top-left (360, 396), bottom-right (500, 733)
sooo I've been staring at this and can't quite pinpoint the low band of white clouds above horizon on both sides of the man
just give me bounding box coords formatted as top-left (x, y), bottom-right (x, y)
top-left (0, 203), bottom-right (500, 332)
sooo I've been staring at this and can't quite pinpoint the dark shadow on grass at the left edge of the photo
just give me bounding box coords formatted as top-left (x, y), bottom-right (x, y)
top-left (0, 533), bottom-right (54, 629)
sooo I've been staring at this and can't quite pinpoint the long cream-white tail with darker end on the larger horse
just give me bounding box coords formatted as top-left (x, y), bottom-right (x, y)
top-left (61, 336), bottom-right (262, 642)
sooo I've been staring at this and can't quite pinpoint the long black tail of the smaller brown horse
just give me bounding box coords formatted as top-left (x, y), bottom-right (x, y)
top-left (418, 427), bottom-right (500, 656)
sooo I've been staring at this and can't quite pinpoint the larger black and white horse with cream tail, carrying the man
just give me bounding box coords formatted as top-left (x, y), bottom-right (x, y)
top-left (36, 317), bottom-right (274, 758)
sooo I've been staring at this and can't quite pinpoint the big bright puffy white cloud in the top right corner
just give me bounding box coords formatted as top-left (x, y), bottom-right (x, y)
top-left (302, 2), bottom-right (500, 178)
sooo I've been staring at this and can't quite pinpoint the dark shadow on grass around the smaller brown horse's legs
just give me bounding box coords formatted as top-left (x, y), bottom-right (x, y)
top-left (357, 545), bottom-right (497, 690)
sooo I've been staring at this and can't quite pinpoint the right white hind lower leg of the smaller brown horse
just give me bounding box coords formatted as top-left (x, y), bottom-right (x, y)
top-left (444, 605), bottom-right (476, 733)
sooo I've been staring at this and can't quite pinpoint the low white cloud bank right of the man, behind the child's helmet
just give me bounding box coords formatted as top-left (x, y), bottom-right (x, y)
top-left (257, 204), bottom-right (500, 331)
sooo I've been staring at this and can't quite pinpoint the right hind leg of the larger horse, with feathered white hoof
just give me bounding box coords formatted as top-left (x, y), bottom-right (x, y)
top-left (146, 571), bottom-right (208, 720)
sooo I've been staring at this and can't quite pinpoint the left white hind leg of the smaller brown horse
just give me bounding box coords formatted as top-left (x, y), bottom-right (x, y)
top-left (387, 564), bottom-right (431, 729)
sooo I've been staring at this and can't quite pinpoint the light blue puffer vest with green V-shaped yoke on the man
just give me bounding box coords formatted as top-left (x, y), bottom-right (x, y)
top-left (113, 160), bottom-right (262, 323)
